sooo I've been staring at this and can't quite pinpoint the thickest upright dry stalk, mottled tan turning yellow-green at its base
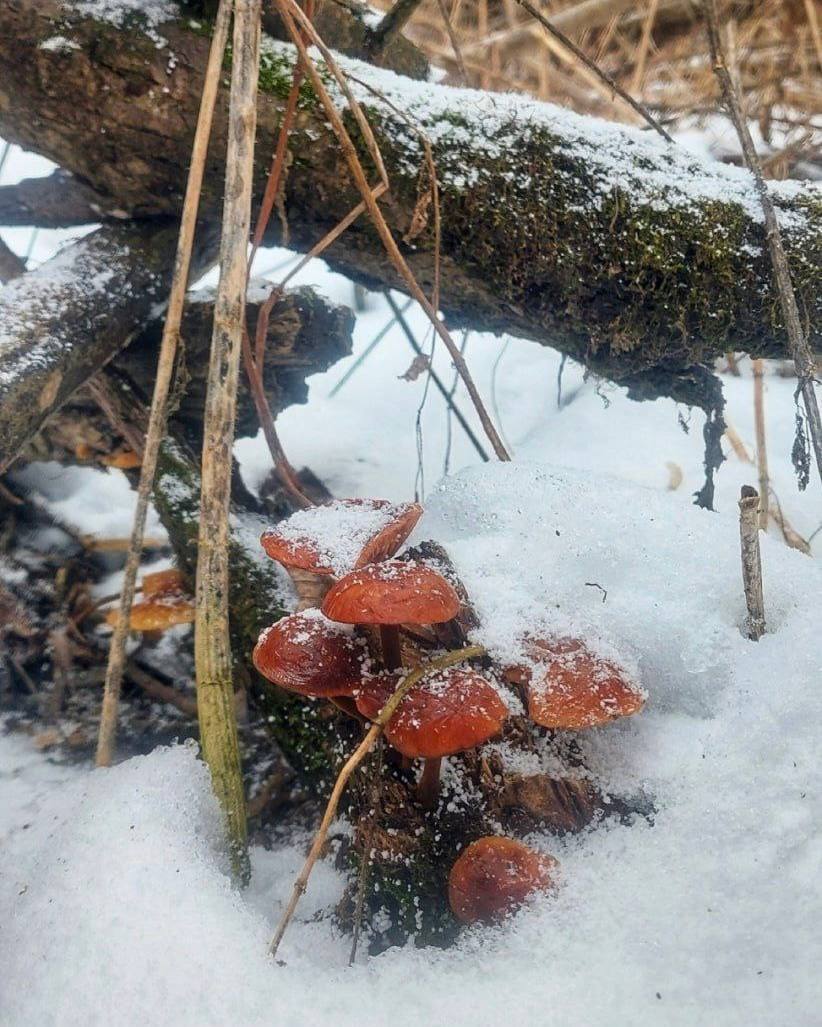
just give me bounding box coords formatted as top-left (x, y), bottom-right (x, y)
top-left (194, 0), bottom-right (260, 879)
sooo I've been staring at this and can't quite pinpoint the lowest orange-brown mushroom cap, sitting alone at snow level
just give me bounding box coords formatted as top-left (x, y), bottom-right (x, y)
top-left (448, 837), bottom-right (559, 923)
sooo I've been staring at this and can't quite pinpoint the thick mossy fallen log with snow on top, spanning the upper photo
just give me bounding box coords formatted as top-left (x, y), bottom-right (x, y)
top-left (0, 0), bottom-right (822, 392)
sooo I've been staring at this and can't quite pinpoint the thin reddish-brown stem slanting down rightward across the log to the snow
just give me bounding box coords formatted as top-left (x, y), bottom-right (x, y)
top-left (276, 0), bottom-right (511, 460)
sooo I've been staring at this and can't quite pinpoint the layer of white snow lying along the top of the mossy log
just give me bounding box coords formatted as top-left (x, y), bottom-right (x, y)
top-left (254, 37), bottom-right (819, 235)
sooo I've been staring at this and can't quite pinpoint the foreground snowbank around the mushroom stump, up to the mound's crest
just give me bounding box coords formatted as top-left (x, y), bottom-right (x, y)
top-left (0, 464), bottom-right (822, 1027)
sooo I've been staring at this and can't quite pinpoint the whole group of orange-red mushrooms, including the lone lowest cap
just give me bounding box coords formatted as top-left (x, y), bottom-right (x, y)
top-left (254, 499), bottom-right (644, 923)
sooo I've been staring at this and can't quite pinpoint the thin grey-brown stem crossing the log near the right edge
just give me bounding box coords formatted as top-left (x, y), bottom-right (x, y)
top-left (702, 0), bottom-right (822, 479)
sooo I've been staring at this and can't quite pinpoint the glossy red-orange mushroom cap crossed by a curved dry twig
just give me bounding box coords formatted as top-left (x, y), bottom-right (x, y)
top-left (356, 668), bottom-right (509, 759)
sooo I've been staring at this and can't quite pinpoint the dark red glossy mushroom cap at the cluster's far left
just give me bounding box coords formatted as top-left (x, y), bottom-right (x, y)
top-left (252, 610), bottom-right (366, 698)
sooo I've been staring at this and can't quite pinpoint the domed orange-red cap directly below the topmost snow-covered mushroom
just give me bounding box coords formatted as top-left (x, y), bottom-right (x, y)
top-left (323, 560), bottom-right (461, 624)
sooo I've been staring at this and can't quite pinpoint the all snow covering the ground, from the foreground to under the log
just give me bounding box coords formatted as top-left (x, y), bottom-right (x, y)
top-left (0, 134), bottom-right (822, 1027)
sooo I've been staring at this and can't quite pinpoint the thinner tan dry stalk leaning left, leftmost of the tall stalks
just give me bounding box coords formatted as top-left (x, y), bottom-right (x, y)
top-left (97, 0), bottom-right (231, 766)
